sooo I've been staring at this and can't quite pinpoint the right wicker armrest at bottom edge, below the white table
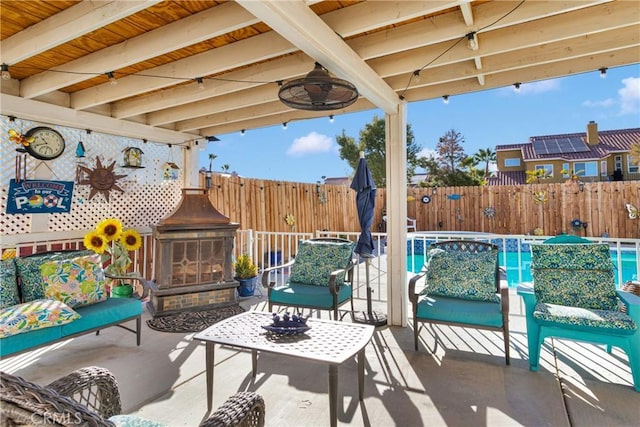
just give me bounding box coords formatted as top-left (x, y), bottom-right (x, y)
top-left (200, 391), bottom-right (264, 427)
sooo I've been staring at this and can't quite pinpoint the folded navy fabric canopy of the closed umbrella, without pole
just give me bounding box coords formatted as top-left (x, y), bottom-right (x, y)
top-left (351, 155), bottom-right (376, 258)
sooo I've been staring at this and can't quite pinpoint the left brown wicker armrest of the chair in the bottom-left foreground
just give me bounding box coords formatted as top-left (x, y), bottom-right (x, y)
top-left (47, 366), bottom-right (122, 418)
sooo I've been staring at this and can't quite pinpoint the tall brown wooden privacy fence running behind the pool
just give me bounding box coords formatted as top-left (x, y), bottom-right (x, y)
top-left (209, 174), bottom-right (640, 238)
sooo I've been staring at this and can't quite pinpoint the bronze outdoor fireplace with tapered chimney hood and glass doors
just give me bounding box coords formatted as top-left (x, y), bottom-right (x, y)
top-left (149, 188), bottom-right (239, 316)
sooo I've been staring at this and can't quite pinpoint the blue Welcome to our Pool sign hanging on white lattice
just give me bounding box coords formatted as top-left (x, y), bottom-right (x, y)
top-left (7, 179), bottom-right (73, 214)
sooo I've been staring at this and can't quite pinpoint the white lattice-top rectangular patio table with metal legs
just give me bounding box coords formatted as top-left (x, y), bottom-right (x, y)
top-left (195, 311), bottom-right (375, 426)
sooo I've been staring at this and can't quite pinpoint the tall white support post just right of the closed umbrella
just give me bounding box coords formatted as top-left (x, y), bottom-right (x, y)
top-left (385, 101), bottom-right (408, 326)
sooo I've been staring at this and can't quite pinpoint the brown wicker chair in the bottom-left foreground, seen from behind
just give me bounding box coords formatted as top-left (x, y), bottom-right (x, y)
top-left (0, 367), bottom-right (264, 427)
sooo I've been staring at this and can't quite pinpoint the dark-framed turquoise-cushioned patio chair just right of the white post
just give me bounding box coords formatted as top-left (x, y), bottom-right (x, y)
top-left (409, 240), bottom-right (510, 365)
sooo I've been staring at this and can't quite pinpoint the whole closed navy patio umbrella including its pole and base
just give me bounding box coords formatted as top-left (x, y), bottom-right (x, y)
top-left (351, 152), bottom-right (387, 326)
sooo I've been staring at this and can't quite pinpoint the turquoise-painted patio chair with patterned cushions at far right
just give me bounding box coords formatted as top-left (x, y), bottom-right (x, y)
top-left (518, 243), bottom-right (640, 391)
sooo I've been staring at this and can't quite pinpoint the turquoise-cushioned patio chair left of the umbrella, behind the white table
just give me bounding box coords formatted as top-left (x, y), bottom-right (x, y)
top-left (262, 238), bottom-right (355, 319)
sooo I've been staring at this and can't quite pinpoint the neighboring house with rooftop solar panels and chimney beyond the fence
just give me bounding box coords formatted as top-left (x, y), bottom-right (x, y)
top-left (489, 121), bottom-right (640, 185)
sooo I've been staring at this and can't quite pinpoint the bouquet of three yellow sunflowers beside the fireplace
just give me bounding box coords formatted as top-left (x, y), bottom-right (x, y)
top-left (84, 218), bottom-right (142, 286)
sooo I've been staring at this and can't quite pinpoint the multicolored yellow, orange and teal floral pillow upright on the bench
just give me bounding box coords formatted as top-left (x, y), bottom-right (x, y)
top-left (40, 254), bottom-right (107, 307)
